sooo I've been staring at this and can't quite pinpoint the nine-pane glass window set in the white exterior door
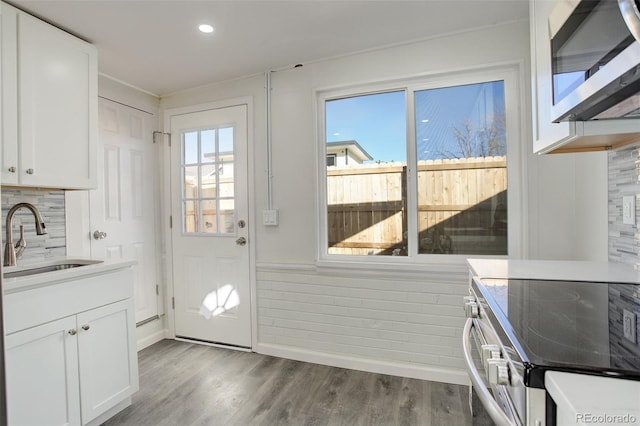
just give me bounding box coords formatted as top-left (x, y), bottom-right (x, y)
top-left (182, 127), bottom-right (235, 234)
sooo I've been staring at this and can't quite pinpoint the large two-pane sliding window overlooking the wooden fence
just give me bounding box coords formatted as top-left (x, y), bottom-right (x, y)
top-left (318, 70), bottom-right (521, 259)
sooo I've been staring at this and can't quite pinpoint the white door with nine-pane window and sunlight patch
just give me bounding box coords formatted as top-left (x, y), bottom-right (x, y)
top-left (169, 105), bottom-right (251, 347)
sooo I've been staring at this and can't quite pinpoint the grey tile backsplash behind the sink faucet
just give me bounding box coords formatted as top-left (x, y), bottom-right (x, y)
top-left (0, 188), bottom-right (67, 264)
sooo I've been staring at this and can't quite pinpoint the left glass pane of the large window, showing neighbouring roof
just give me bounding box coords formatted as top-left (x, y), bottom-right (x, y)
top-left (325, 90), bottom-right (407, 255)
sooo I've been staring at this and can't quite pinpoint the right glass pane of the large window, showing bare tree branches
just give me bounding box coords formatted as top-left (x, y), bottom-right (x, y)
top-left (414, 81), bottom-right (507, 255)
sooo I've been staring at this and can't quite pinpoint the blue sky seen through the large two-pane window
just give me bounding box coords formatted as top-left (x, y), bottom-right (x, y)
top-left (325, 81), bottom-right (504, 162)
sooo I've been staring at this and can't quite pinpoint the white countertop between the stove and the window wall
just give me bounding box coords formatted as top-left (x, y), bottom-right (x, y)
top-left (467, 259), bottom-right (640, 283)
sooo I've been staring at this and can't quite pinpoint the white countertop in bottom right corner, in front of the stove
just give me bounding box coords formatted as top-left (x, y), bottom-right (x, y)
top-left (545, 371), bottom-right (640, 425)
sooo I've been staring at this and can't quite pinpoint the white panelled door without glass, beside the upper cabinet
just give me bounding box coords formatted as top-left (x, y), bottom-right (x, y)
top-left (90, 98), bottom-right (158, 323)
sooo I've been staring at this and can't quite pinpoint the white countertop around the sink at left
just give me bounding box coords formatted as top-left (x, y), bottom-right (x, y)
top-left (2, 257), bottom-right (136, 294)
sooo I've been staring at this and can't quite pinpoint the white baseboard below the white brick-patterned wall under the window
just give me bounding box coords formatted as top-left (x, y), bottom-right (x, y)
top-left (253, 343), bottom-right (469, 386)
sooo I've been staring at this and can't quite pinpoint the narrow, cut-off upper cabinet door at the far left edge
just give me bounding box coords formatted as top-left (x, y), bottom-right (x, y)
top-left (0, 3), bottom-right (18, 185)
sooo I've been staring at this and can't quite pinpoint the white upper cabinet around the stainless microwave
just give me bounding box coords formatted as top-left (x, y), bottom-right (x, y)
top-left (529, 0), bottom-right (640, 153)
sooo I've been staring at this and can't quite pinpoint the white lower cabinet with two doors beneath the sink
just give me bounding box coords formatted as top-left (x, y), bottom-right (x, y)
top-left (5, 268), bottom-right (139, 426)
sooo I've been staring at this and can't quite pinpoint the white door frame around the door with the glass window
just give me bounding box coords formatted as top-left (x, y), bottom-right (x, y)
top-left (159, 96), bottom-right (258, 350)
